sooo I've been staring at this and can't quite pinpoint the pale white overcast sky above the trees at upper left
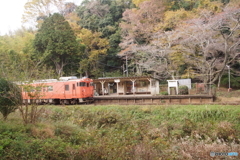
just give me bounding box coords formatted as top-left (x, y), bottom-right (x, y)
top-left (0, 0), bottom-right (81, 35)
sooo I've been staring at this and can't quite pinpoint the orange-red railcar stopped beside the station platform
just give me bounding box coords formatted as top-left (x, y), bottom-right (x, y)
top-left (21, 76), bottom-right (94, 105)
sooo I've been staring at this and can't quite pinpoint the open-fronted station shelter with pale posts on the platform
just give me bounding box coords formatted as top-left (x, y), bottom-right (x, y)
top-left (93, 76), bottom-right (159, 96)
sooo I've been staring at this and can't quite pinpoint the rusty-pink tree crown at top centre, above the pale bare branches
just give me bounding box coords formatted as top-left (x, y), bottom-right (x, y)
top-left (120, 0), bottom-right (164, 49)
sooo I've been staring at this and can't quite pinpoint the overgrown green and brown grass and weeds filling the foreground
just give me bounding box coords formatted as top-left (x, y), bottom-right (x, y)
top-left (0, 105), bottom-right (240, 160)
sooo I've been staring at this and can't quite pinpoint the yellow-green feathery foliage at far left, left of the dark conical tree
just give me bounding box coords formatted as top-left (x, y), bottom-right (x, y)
top-left (0, 28), bottom-right (53, 81)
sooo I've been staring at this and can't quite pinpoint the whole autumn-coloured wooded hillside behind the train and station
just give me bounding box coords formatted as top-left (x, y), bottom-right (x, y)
top-left (0, 0), bottom-right (240, 87)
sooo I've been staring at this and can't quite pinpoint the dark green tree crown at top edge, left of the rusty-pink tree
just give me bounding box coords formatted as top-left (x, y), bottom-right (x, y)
top-left (76, 0), bottom-right (132, 38)
